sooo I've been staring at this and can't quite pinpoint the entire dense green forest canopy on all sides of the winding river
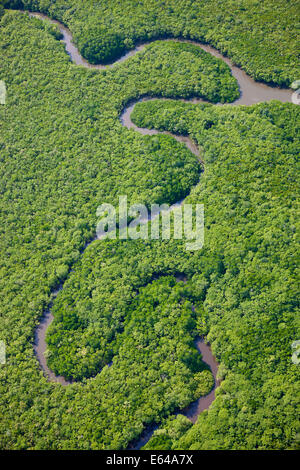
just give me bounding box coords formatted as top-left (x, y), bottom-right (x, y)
top-left (0, 0), bottom-right (300, 449)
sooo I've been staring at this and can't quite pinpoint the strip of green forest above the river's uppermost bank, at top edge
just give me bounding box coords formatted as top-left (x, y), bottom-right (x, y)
top-left (5, 0), bottom-right (300, 85)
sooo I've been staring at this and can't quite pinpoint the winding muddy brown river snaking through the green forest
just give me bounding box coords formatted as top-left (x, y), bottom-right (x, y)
top-left (24, 13), bottom-right (293, 449)
